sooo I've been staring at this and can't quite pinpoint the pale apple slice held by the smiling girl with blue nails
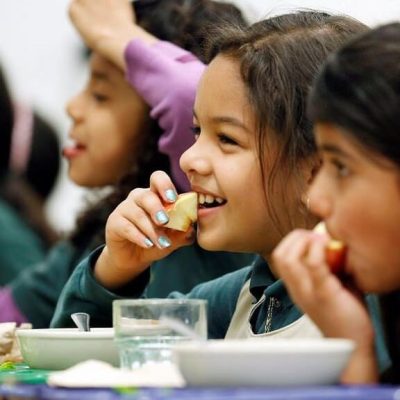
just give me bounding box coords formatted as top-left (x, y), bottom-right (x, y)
top-left (164, 192), bottom-right (197, 232)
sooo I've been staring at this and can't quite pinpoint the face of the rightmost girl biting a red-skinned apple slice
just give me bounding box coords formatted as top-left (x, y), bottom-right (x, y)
top-left (310, 123), bottom-right (400, 293)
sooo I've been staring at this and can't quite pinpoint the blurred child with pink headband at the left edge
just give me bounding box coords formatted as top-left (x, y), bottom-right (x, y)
top-left (0, 61), bottom-right (60, 285)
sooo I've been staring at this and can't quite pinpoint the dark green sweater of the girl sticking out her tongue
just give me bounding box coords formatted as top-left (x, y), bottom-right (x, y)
top-left (10, 241), bottom-right (254, 328)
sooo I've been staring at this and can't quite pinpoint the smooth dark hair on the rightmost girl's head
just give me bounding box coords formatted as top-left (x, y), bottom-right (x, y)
top-left (309, 23), bottom-right (400, 166)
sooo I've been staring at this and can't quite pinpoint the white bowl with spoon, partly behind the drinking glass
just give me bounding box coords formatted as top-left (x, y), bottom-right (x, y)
top-left (16, 328), bottom-right (119, 370)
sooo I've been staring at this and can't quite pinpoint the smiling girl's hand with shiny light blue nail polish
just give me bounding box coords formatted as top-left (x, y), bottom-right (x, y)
top-left (95, 171), bottom-right (194, 288)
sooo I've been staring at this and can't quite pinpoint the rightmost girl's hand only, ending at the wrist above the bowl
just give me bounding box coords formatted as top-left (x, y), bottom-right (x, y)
top-left (273, 229), bottom-right (371, 338)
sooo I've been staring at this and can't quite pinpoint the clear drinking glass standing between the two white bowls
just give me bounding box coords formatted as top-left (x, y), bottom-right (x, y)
top-left (113, 299), bottom-right (207, 369)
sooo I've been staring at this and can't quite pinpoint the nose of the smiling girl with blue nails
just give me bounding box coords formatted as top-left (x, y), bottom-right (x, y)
top-left (179, 138), bottom-right (211, 180)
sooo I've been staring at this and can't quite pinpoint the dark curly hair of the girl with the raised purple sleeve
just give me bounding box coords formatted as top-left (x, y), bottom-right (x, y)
top-left (71, 0), bottom-right (246, 248)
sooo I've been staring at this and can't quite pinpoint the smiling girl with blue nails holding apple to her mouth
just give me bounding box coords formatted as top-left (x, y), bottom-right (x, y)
top-left (49, 12), bottom-right (390, 368)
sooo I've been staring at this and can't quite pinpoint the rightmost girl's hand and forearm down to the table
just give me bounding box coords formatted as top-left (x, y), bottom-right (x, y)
top-left (272, 230), bottom-right (378, 383)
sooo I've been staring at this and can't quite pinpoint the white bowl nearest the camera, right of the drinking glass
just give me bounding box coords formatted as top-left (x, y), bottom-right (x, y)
top-left (174, 339), bottom-right (354, 386)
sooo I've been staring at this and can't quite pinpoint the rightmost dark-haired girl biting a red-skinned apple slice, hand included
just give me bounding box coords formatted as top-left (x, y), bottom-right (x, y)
top-left (274, 24), bottom-right (400, 383)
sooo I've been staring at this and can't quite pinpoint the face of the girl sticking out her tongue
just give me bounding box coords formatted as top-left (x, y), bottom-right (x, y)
top-left (64, 53), bottom-right (149, 187)
